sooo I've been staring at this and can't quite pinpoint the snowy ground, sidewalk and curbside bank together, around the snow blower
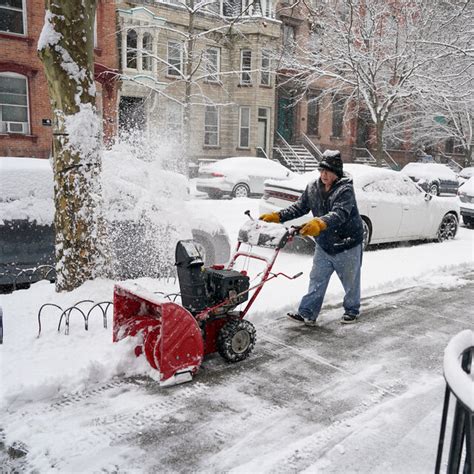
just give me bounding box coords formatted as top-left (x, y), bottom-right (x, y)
top-left (0, 199), bottom-right (474, 473)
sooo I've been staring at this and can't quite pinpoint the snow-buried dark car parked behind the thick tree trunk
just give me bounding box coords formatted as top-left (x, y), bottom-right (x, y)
top-left (0, 151), bottom-right (230, 289)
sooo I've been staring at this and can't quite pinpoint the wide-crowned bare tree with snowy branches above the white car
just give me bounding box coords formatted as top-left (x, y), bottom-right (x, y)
top-left (286, 0), bottom-right (473, 164)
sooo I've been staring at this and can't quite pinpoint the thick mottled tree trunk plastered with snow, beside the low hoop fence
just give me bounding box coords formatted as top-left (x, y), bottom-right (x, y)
top-left (38, 0), bottom-right (102, 291)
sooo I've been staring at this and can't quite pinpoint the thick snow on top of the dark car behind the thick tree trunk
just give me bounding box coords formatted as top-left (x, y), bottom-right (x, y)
top-left (0, 147), bottom-right (188, 225)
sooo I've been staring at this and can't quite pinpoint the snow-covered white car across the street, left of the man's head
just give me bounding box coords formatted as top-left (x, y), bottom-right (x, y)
top-left (196, 156), bottom-right (296, 199)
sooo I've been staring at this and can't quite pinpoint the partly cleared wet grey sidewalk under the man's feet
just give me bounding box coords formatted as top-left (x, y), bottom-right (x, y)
top-left (0, 271), bottom-right (474, 473)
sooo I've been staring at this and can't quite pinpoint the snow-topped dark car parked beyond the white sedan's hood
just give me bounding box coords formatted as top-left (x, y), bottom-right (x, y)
top-left (401, 163), bottom-right (459, 196)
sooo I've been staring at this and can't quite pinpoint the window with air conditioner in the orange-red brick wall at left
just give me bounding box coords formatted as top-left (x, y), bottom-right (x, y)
top-left (0, 72), bottom-right (29, 134)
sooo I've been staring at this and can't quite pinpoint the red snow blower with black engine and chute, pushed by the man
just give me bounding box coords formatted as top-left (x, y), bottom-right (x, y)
top-left (113, 211), bottom-right (302, 385)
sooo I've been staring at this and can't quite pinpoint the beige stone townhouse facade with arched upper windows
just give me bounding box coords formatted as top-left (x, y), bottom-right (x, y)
top-left (117, 1), bottom-right (281, 162)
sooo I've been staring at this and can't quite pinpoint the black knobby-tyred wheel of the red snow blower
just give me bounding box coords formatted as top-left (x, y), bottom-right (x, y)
top-left (217, 319), bottom-right (256, 362)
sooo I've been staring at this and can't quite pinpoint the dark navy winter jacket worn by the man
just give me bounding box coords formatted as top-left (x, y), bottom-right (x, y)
top-left (279, 176), bottom-right (364, 255)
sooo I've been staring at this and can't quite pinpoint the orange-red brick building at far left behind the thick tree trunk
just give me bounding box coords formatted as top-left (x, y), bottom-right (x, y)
top-left (0, 0), bottom-right (117, 158)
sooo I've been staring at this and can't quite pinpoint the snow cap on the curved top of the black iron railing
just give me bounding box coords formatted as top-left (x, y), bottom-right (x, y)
top-left (443, 329), bottom-right (474, 411)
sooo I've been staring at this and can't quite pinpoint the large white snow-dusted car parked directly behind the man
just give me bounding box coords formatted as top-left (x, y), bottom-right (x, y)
top-left (259, 164), bottom-right (459, 248)
